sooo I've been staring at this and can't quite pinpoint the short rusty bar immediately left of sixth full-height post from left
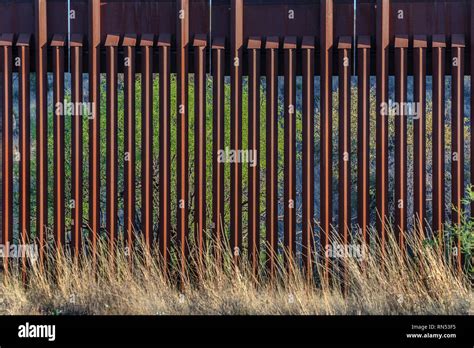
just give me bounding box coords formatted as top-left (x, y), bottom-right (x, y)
top-left (357, 36), bottom-right (370, 243)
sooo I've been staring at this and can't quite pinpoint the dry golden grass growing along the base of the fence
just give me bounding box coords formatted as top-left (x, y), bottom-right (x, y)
top-left (0, 228), bottom-right (474, 314)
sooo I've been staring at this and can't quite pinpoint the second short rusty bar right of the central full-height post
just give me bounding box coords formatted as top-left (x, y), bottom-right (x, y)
top-left (265, 37), bottom-right (279, 278)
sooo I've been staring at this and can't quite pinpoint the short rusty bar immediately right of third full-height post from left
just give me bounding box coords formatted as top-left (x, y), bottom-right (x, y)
top-left (193, 34), bottom-right (207, 265)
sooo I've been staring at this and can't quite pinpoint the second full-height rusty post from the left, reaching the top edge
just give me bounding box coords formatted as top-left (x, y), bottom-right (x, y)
top-left (88, 0), bottom-right (101, 267)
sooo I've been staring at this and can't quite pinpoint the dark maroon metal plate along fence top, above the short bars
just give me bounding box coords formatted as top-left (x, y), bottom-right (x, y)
top-left (0, 0), bottom-right (471, 74)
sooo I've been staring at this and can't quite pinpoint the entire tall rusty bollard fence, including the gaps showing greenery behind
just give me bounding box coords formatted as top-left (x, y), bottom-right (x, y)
top-left (0, 0), bottom-right (474, 274)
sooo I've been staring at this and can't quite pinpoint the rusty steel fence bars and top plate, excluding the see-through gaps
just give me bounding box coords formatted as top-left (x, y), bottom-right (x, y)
top-left (0, 0), bottom-right (474, 274)
